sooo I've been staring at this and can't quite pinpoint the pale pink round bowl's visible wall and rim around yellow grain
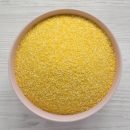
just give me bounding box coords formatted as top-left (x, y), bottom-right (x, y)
top-left (8, 9), bottom-right (121, 122)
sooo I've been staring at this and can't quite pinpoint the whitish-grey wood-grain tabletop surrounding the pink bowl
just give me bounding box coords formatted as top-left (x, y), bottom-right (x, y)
top-left (0, 0), bottom-right (130, 130)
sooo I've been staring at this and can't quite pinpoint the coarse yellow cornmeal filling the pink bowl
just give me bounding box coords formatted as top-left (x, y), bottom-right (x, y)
top-left (15, 15), bottom-right (116, 115)
